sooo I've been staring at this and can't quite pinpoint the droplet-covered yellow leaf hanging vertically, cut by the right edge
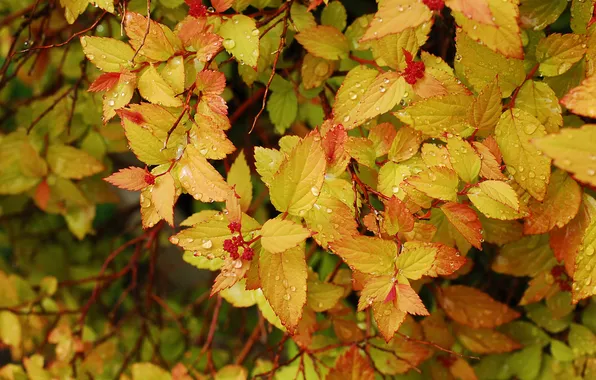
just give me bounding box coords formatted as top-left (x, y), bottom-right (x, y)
top-left (572, 196), bottom-right (596, 304)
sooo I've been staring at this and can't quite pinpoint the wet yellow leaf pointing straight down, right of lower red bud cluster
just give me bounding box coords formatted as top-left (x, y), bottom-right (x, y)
top-left (259, 246), bottom-right (307, 333)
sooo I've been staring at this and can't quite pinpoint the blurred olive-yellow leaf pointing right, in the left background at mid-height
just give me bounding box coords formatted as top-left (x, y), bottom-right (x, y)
top-left (47, 145), bottom-right (104, 179)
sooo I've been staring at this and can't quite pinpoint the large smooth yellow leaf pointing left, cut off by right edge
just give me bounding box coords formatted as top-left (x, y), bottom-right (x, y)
top-left (533, 124), bottom-right (596, 186)
